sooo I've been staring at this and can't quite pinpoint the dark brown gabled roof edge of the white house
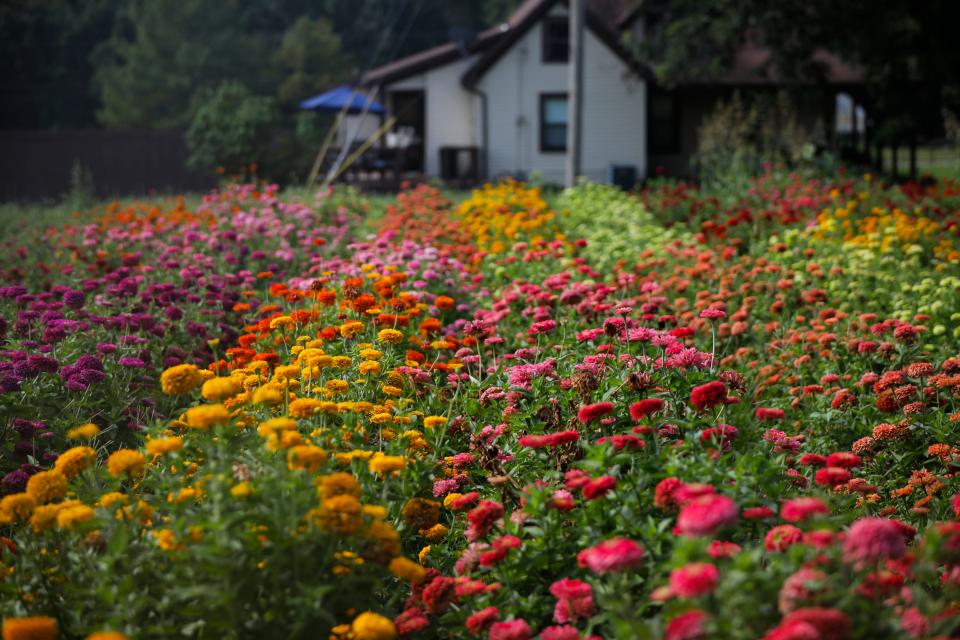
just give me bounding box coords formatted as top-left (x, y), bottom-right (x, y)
top-left (360, 0), bottom-right (649, 86)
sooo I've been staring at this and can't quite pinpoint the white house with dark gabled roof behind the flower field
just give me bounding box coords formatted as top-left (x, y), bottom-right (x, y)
top-left (362, 0), bottom-right (857, 183)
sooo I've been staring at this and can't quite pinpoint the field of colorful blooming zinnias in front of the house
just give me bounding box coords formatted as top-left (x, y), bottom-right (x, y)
top-left (0, 174), bottom-right (960, 640)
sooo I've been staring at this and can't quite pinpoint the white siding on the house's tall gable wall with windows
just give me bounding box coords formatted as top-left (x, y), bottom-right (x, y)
top-left (474, 10), bottom-right (647, 183)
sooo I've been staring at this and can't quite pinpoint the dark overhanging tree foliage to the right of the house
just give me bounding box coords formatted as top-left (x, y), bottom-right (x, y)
top-left (639, 0), bottom-right (960, 141)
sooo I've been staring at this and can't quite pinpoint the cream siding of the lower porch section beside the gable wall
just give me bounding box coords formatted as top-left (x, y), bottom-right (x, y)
top-left (386, 56), bottom-right (479, 175)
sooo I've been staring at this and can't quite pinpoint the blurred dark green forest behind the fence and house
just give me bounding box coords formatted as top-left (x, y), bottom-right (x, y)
top-left (0, 0), bottom-right (517, 129)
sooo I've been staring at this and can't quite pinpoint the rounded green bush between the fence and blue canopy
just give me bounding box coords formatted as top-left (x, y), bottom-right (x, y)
top-left (187, 81), bottom-right (278, 175)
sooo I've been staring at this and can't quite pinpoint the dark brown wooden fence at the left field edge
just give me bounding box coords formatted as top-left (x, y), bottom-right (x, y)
top-left (0, 130), bottom-right (216, 201)
